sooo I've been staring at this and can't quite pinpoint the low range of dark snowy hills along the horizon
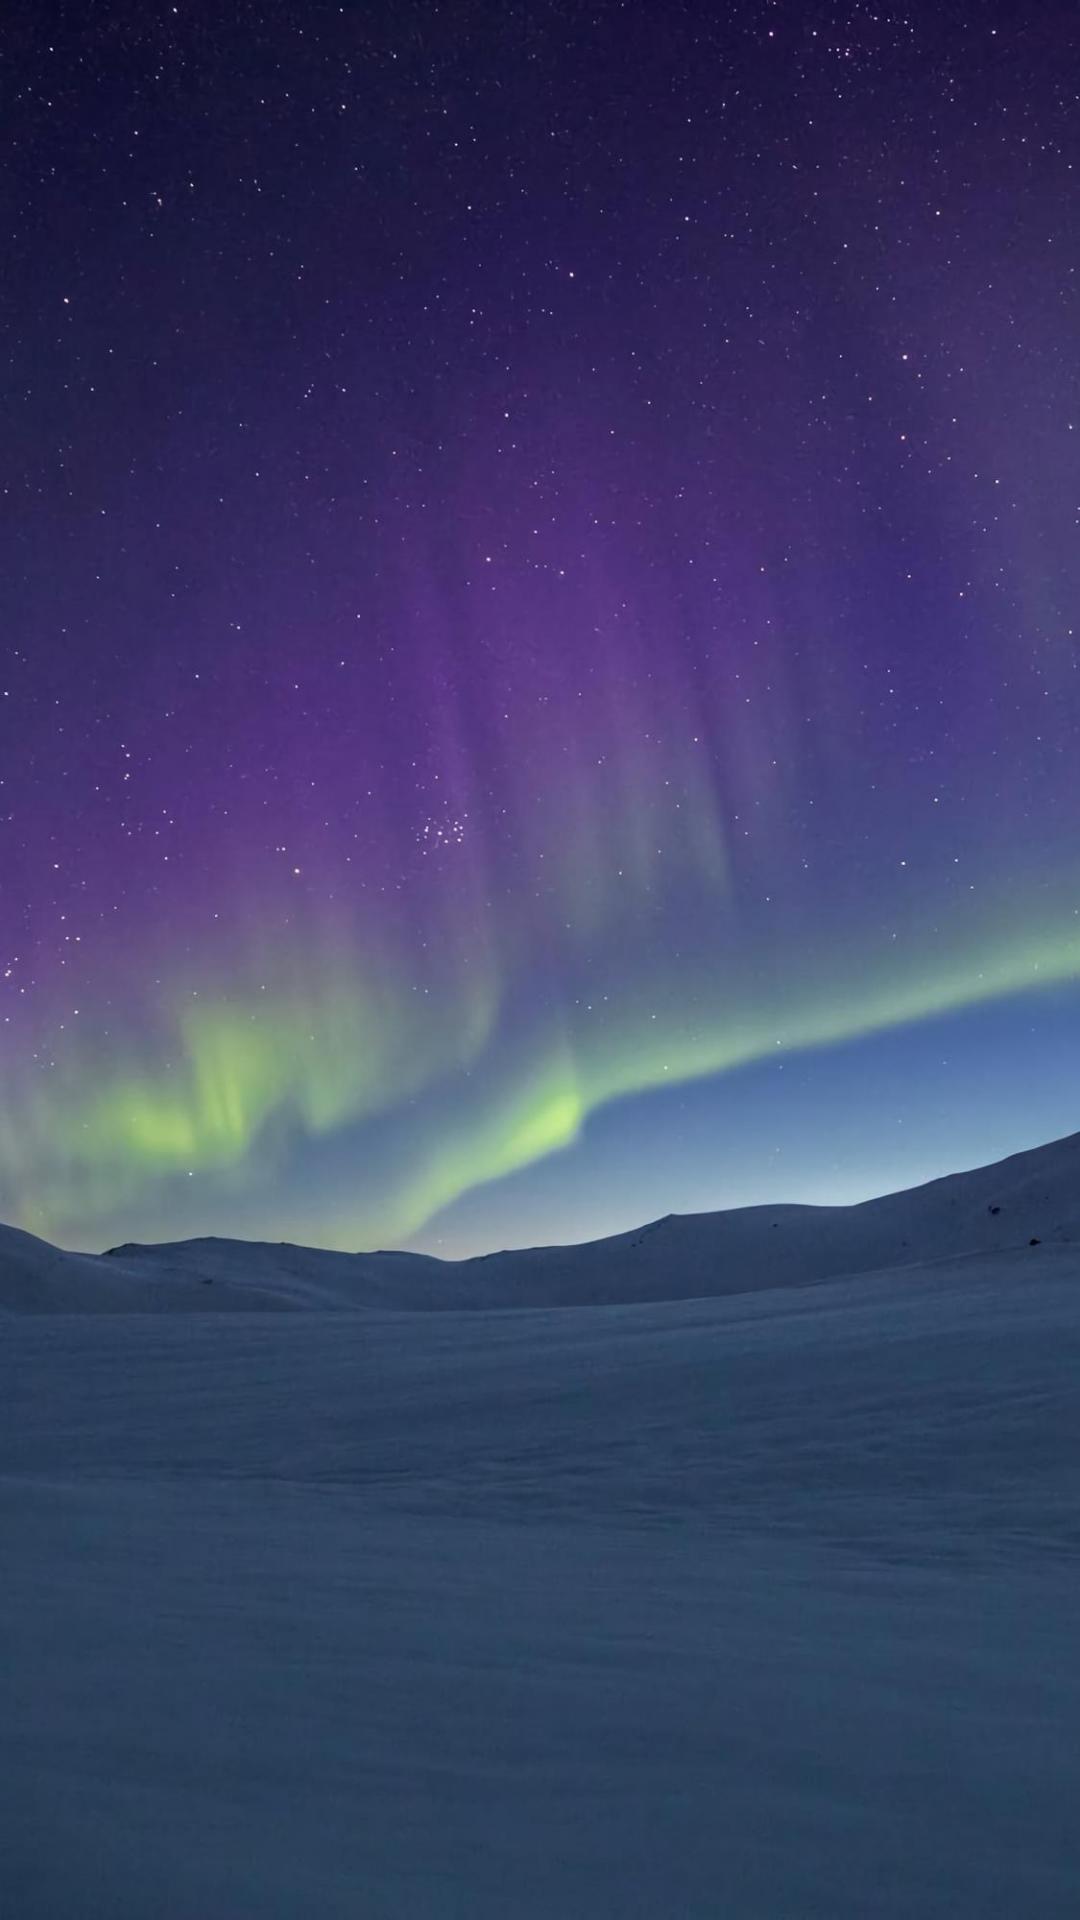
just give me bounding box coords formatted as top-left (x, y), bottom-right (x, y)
top-left (0, 1135), bottom-right (1080, 1311)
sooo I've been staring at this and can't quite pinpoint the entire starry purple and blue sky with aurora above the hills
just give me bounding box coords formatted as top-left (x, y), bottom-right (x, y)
top-left (0, 0), bottom-right (1080, 1256)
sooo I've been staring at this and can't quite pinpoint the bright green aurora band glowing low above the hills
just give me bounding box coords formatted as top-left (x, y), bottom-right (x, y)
top-left (10, 871), bottom-right (1080, 1248)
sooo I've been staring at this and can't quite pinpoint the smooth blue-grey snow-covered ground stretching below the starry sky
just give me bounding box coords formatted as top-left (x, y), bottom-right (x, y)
top-left (0, 1142), bottom-right (1080, 1920)
